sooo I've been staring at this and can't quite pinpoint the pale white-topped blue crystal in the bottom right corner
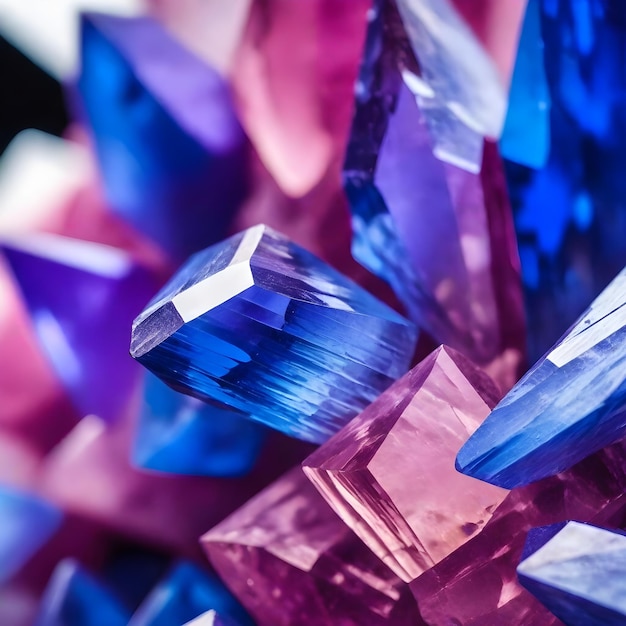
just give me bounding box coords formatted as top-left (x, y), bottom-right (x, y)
top-left (517, 522), bottom-right (626, 626)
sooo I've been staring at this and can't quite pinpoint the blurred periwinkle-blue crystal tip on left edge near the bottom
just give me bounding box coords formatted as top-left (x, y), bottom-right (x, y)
top-left (0, 486), bottom-right (62, 584)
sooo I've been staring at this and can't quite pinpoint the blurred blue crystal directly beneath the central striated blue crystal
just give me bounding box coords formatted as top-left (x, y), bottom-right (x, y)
top-left (133, 373), bottom-right (266, 476)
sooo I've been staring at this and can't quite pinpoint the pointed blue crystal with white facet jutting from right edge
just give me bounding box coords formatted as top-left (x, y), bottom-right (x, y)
top-left (457, 270), bottom-right (626, 488)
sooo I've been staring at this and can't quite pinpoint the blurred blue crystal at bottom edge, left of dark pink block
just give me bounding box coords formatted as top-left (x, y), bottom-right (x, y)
top-left (128, 562), bottom-right (252, 626)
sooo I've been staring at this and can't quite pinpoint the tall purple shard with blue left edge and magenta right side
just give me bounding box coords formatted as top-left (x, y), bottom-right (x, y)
top-left (343, 2), bottom-right (524, 376)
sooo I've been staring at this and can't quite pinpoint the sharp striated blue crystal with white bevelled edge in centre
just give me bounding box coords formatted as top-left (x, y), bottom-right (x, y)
top-left (131, 225), bottom-right (416, 442)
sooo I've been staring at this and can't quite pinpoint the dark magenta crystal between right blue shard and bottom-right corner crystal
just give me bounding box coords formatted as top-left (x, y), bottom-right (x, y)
top-left (411, 442), bottom-right (626, 626)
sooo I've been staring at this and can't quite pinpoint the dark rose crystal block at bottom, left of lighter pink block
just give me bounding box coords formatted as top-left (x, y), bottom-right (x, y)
top-left (201, 468), bottom-right (422, 626)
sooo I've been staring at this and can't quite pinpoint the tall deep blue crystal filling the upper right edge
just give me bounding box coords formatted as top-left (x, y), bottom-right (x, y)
top-left (501, 0), bottom-right (626, 359)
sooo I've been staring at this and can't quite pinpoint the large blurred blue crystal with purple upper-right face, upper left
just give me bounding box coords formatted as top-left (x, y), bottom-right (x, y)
top-left (78, 14), bottom-right (247, 260)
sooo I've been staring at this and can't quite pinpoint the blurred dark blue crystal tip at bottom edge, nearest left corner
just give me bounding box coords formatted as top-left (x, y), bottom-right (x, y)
top-left (35, 559), bottom-right (130, 626)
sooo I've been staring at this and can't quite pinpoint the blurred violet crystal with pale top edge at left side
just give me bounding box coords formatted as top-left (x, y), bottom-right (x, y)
top-left (0, 234), bottom-right (158, 422)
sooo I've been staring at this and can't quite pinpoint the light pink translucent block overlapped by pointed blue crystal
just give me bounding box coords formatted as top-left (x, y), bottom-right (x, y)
top-left (303, 346), bottom-right (508, 582)
